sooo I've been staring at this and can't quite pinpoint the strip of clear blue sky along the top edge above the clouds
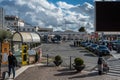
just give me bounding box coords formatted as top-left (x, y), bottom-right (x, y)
top-left (48, 0), bottom-right (93, 5)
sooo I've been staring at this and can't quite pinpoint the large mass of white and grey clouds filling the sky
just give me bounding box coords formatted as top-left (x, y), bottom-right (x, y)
top-left (0, 0), bottom-right (94, 31)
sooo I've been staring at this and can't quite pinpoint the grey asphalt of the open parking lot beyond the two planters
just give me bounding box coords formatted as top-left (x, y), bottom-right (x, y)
top-left (41, 41), bottom-right (97, 69)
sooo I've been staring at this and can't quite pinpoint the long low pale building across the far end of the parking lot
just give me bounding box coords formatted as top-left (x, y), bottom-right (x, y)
top-left (38, 31), bottom-right (89, 40)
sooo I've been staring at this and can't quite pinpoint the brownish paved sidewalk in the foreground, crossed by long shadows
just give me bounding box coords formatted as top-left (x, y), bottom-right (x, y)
top-left (12, 66), bottom-right (120, 80)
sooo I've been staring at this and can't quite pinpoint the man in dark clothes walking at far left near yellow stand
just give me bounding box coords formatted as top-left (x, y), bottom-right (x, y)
top-left (8, 51), bottom-right (16, 79)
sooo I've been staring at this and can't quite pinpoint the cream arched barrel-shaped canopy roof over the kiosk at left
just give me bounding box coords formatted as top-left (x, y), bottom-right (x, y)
top-left (12, 32), bottom-right (41, 43)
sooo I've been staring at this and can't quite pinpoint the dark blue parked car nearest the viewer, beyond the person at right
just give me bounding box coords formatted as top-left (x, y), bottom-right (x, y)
top-left (94, 45), bottom-right (110, 56)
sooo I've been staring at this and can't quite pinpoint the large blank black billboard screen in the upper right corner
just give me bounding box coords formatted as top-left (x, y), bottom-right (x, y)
top-left (95, 1), bottom-right (120, 32)
